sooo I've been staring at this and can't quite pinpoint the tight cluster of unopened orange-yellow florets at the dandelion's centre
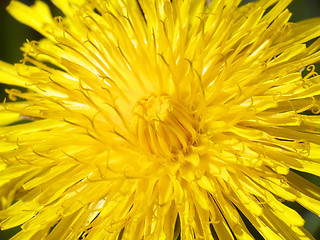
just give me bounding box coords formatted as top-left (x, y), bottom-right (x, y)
top-left (131, 96), bottom-right (198, 159)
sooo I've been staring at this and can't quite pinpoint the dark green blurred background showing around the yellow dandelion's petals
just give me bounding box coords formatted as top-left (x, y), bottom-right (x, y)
top-left (0, 0), bottom-right (320, 240)
